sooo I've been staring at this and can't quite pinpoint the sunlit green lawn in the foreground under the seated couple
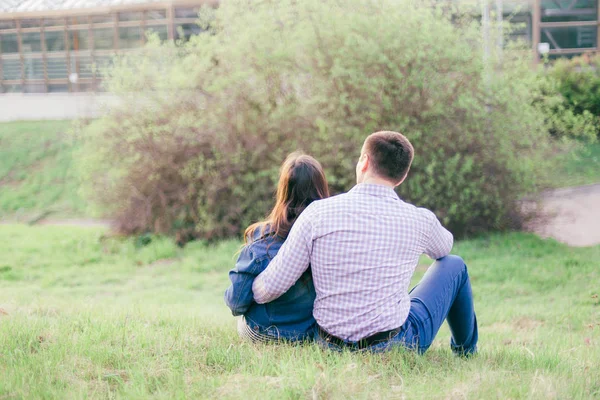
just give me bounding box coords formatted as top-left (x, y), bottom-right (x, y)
top-left (0, 225), bottom-right (600, 400)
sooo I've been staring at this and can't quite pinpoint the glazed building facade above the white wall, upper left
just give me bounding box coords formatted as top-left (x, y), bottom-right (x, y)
top-left (0, 0), bottom-right (216, 93)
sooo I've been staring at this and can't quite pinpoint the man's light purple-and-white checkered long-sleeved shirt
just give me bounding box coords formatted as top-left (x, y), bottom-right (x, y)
top-left (252, 184), bottom-right (453, 341)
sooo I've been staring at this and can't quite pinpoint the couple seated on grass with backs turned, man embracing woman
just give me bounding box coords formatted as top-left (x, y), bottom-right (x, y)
top-left (225, 131), bottom-right (478, 356)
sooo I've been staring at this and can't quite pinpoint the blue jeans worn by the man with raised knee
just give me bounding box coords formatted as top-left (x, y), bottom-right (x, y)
top-left (317, 255), bottom-right (478, 355)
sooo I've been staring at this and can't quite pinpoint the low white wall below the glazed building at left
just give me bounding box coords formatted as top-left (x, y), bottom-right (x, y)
top-left (0, 93), bottom-right (116, 121)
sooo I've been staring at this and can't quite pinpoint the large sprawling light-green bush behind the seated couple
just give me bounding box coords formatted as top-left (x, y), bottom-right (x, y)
top-left (80, 0), bottom-right (549, 240)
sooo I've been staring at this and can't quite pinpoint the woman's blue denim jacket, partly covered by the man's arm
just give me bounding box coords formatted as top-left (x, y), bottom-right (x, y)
top-left (225, 229), bottom-right (316, 341)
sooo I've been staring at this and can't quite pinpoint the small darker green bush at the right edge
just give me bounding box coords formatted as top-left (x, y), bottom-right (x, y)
top-left (542, 55), bottom-right (600, 141)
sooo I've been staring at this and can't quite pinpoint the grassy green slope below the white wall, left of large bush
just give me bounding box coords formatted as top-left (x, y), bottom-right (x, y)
top-left (0, 121), bottom-right (85, 220)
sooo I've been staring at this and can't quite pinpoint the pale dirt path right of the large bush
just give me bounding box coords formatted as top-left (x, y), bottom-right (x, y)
top-left (529, 184), bottom-right (600, 247)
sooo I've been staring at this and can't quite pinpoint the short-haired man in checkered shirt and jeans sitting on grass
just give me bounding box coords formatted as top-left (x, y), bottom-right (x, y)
top-left (252, 131), bottom-right (478, 355)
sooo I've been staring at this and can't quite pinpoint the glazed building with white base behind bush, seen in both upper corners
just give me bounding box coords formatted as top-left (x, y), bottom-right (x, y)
top-left (0, 0), bottom-right (600, 120)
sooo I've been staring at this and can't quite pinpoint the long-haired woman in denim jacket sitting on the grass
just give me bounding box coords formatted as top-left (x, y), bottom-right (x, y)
top-left (225, 152), bottom-right (329, 342)
